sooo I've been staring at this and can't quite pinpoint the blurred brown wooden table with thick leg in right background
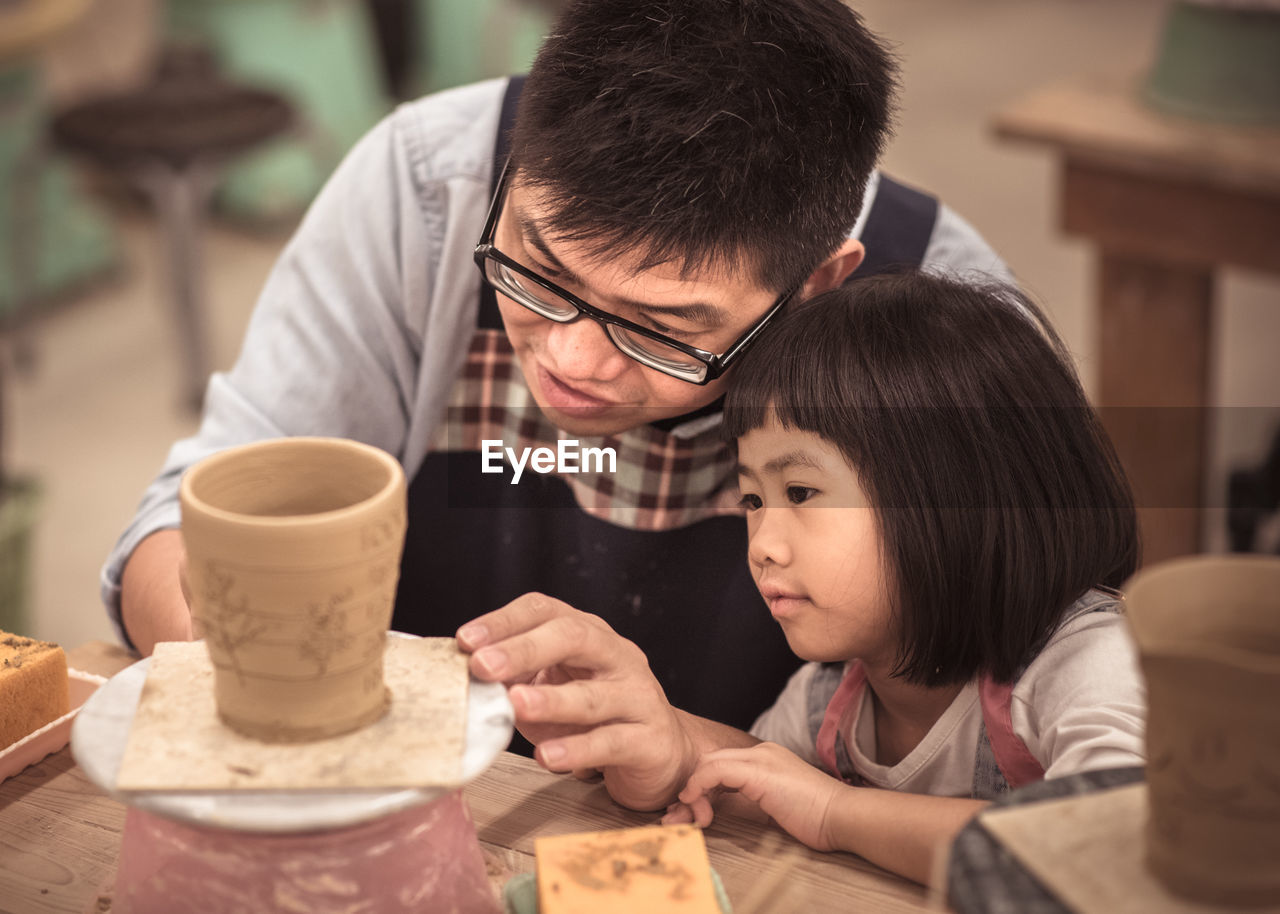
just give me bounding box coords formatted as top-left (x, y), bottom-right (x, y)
top-left (993, 77), bottom-right (1280, 562)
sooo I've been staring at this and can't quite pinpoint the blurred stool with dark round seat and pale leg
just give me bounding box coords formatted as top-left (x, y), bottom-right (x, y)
top-left (52, 47), bottom-right (293, 410)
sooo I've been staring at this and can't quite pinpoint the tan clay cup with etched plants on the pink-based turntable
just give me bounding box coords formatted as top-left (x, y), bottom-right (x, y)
top-left (180, 438), bottom-right (406, 742)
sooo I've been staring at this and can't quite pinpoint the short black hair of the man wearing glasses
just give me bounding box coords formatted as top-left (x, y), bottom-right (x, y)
top-left (512, 0), bottom-right (896, 292)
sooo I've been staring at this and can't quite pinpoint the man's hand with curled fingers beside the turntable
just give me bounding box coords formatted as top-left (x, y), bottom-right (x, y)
top-left (458, 594), bottom-right (698, 809)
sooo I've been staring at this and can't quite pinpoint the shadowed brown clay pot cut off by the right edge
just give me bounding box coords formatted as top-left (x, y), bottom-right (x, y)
top-left (1125, 556), bottom-right (1280, 905)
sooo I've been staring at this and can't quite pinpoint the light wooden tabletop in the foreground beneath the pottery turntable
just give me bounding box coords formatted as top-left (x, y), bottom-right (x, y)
top-left (0, 641), bottom-right (932, 914)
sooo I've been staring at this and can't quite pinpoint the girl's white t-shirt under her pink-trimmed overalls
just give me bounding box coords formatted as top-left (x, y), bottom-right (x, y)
top-left (751, 612), bottom-right (1147, 796)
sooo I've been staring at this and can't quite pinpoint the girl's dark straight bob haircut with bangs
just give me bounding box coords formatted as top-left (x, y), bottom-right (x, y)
top-left (724, 273), bottom-right (1138, 686)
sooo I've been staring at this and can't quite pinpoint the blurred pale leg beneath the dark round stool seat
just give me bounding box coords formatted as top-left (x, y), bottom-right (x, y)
top-left (141, 165), bottom-right (214, 411)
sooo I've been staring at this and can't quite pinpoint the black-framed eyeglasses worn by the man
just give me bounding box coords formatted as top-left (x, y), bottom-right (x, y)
top-left (475, 159), bottom-right (799, 387)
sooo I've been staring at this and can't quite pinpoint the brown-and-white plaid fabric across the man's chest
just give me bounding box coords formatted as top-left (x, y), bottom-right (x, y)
top-left (431, 329), bottom-right (741, 530)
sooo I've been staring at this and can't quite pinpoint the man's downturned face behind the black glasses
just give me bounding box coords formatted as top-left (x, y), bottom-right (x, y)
top-left (494, 182), bottom-right (777, 435)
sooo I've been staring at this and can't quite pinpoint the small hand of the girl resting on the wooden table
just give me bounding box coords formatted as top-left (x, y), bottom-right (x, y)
top-left (663, 742), bottom-right (845, 850)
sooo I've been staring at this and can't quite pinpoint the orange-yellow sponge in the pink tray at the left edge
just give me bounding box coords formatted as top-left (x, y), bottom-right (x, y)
top-left (0, 631), bottom-right (70, 749)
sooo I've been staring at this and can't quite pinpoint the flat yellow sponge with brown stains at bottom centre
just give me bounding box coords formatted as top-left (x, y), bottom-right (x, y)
top-left (534, 826), bottom-right (721, 914)
